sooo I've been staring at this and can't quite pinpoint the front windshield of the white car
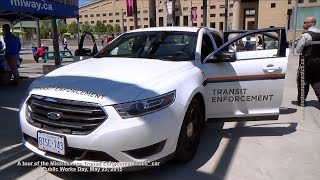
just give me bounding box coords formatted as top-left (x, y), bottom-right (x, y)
top-left (94, 31), bottom-right (197, 61)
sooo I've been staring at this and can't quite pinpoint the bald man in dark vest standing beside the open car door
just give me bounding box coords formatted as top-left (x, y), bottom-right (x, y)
top-left (292, 16), bottom-right (320, 106)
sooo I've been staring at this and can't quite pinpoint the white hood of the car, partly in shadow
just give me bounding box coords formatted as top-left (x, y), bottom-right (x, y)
top-left (31, 58), bottom-right (194, 105)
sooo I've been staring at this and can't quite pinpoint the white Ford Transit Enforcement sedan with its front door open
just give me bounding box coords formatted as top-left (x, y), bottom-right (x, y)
top-left (20, 27), bottom-right (288, 167)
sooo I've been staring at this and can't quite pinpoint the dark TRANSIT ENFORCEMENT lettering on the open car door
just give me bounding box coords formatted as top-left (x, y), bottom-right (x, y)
top-left (212, 88), bottom-right (273, 102)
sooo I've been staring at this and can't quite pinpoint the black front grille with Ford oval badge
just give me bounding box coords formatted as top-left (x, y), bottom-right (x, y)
top-left (26, 95), bottom-right (108, 135)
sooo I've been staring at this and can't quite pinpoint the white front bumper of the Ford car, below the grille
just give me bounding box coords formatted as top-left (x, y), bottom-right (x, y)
top-left (20, 100), bottom-right (184, 167)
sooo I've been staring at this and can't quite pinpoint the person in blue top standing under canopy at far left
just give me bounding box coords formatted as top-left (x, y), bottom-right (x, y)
top-left (2, 24), bottom-right (21, 85)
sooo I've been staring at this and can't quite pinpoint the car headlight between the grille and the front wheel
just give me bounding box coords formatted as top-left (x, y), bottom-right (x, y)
top-left (113, 91), bottom-right (176, 119)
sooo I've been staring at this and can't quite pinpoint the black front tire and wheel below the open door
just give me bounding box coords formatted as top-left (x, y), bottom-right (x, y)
top-left (175, 99), bottom-right (204, 163)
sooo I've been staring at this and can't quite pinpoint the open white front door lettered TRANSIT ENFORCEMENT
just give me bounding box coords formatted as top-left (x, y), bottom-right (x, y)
top-left (203, 28), bottom-right (288, 120)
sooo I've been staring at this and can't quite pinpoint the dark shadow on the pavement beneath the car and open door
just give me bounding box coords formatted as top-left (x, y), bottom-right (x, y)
top-left (43, 122), bottom-right (297, 180)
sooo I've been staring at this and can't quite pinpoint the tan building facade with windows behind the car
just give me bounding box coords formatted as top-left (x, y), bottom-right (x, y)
top-left (73, 0), bottom-right (320, 38)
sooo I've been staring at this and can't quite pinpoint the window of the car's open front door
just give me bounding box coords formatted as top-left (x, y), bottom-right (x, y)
top-left (229, 33), bottom-right (278, 52)
